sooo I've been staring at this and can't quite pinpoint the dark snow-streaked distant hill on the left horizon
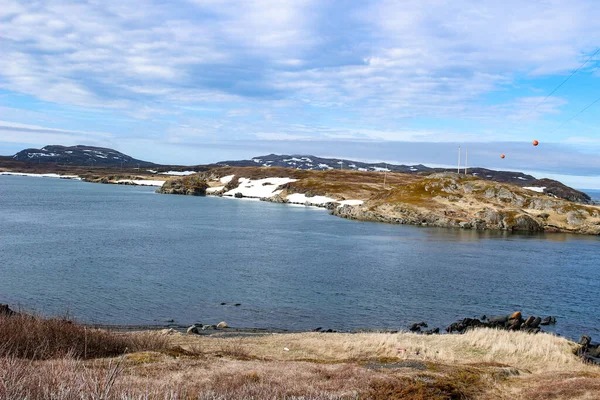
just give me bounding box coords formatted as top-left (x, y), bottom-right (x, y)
top-left (12, 145), bottom-right (156, 167)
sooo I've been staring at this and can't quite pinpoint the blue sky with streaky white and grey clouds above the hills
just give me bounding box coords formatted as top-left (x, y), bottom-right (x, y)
top-left (0, 0), bottom-right (600, 189)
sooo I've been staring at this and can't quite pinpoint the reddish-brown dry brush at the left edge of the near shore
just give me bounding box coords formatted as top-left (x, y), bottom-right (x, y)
top-left (0, 314), bottom-right (167, 360)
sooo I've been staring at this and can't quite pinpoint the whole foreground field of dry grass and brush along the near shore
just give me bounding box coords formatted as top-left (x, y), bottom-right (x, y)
top-left (0, 316), bottom-right (600, 400)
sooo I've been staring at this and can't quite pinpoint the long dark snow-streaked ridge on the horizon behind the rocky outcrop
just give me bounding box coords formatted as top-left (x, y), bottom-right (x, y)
top-left (217, 154), bottom-right (591, 204)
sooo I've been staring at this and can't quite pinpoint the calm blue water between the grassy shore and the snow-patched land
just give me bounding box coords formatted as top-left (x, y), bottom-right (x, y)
top-left (0, 176), bottom-right (600, 337)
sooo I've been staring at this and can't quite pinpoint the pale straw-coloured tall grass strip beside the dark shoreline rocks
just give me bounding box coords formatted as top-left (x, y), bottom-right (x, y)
top-left (173, 329), bottom-right (592, 373)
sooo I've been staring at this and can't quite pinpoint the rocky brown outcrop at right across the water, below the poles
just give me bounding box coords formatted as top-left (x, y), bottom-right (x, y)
top-left (331, 172), bottom-right (600, 235)
